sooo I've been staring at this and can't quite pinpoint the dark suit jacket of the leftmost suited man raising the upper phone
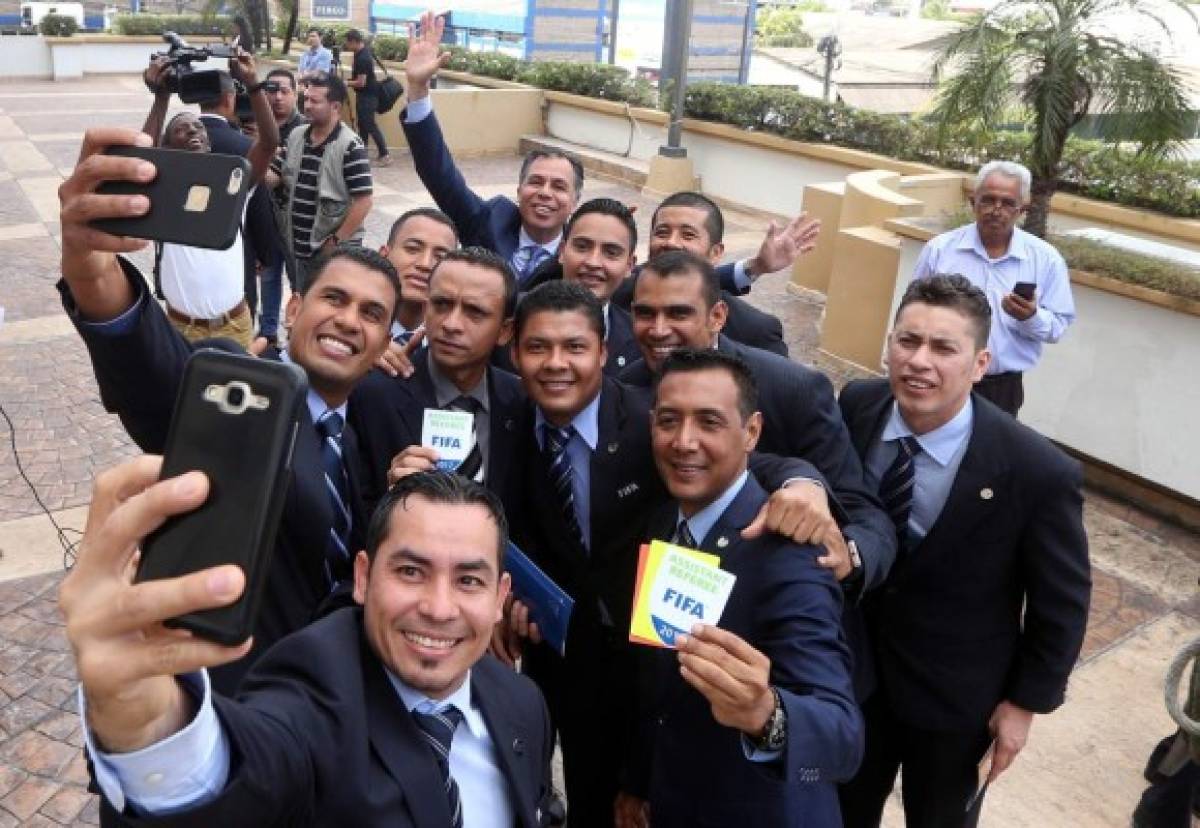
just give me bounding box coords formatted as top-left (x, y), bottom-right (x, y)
top-left (59, 259), bottom-right (367, 694)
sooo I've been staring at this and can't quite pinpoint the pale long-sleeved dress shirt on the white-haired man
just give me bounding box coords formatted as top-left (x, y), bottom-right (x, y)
top-left (912, 224), bottom-right (1075, 373)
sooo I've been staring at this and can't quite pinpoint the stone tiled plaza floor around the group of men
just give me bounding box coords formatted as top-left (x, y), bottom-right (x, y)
top-left (0, 78), bottom-right (1200, 828)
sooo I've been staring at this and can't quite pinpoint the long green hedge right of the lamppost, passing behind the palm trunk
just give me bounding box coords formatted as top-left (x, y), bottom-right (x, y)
top-left (684, 83), bottom-right (1200, 217)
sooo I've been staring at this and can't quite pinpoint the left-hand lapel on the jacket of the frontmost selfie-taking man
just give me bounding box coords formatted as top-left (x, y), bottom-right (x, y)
top-left (360, 636), bottom-right (450, 828)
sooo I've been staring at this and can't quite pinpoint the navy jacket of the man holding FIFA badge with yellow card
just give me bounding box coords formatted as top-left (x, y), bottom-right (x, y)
top-left (630, 478), bottom-right (863, 828)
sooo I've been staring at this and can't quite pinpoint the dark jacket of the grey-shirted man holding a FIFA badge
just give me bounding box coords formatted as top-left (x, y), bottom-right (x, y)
top-left (348, 348), bottom-right (524, 512)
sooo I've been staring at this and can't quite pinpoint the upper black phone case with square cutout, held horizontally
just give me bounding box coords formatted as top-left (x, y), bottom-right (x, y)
top-left (91, 146), bottom-right (250, 250)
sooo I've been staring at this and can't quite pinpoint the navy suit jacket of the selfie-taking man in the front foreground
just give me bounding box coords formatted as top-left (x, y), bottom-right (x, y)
top-left (102, 608), bottom-right (554, 828)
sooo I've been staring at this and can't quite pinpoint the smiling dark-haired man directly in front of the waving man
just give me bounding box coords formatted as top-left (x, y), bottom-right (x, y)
top-left (524, 198), bottom-right (641, 377)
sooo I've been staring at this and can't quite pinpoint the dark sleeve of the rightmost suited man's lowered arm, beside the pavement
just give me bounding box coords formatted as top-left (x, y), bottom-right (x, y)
top-left (1006, 445), bottom-right (1092, 713)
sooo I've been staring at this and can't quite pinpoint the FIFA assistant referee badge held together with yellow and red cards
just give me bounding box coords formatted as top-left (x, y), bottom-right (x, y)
top-left (629, 540), bottom-right (737, 648)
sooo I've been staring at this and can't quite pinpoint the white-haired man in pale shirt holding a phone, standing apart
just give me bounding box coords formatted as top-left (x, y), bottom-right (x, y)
top-left (912, 161), bottom-right (1075, 416)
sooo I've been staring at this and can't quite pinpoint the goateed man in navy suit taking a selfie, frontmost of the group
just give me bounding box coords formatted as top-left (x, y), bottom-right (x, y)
top-left (60, 468), bottom-right (554, 828)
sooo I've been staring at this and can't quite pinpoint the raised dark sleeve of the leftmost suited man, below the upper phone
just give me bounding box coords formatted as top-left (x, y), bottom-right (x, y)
top-left (58, 258), bottom-right (192, 454)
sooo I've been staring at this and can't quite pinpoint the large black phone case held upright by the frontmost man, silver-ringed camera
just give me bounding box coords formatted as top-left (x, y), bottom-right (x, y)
top-left (137, 349), bottom-right (307, 644)
